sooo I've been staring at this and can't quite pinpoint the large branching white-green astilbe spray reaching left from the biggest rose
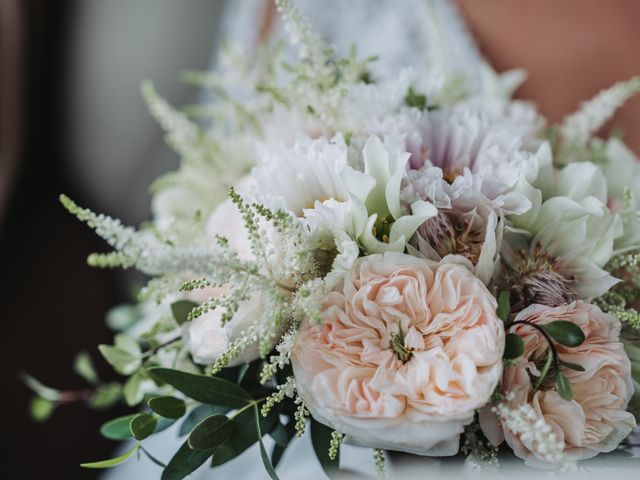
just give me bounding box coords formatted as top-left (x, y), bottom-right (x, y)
top-left (61, 190), bottom-right (324, 371)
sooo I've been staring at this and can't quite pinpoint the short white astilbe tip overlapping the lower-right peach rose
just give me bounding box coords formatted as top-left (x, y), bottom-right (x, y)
top-left (492, 398), bottom-right (570, 467)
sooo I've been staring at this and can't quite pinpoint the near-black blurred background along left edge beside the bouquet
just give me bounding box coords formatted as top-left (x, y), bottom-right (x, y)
top-left (0, 0), bottom-right (129, 479)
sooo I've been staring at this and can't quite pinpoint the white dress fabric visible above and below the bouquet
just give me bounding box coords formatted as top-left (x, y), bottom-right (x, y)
top-left (104, 0), bottom-right (637, 480)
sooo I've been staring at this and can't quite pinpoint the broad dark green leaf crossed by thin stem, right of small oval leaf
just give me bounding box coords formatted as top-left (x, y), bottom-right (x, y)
top-left (211, 402), bottom-right (278, 467)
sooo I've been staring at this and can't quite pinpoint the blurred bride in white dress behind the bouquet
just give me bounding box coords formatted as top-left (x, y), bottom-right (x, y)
top-left (105, 0), bottom-right (640, 480)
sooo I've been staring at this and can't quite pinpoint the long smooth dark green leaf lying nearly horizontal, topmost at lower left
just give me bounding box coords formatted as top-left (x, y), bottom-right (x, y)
top-left (149, 368), bottom-right (253, 408)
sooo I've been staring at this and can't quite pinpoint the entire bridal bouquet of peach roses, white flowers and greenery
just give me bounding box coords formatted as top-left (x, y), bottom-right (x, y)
top-left (27, 0), bottom-right (640, 480)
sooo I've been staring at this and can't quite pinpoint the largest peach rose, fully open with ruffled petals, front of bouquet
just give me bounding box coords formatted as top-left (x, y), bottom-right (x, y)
top-left (292, 253), bottom-right (504, 455)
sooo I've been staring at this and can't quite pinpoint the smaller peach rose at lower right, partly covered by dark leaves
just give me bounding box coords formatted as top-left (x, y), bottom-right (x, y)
top-left (502, 301), bottom-right (635, 465)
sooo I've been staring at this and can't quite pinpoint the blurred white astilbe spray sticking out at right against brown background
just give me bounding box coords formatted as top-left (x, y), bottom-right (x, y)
top-left (560, 76), bottom-right (640, 145)
